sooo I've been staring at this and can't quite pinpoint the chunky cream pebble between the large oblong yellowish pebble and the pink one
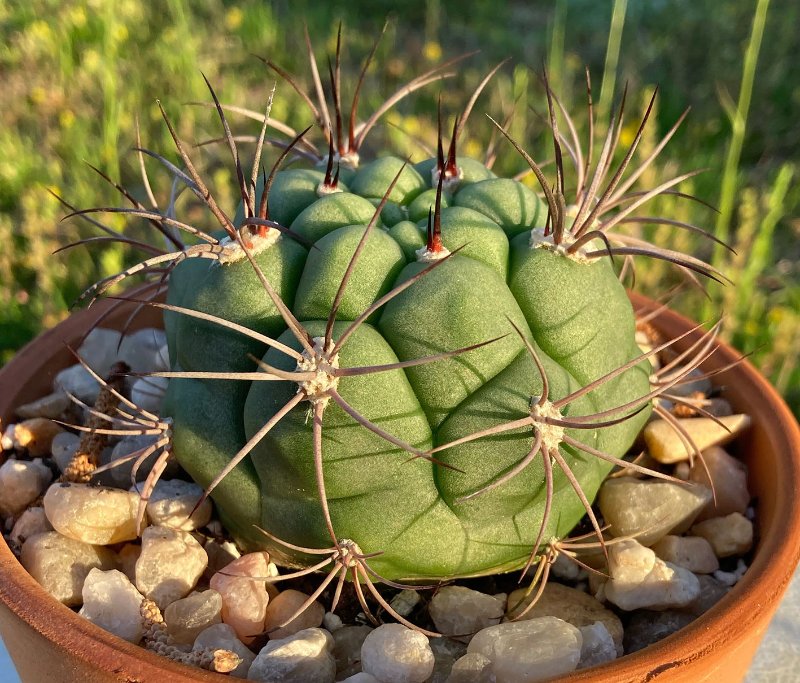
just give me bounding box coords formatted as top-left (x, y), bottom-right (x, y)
top-left (136, 526), bottom-right (208, 610)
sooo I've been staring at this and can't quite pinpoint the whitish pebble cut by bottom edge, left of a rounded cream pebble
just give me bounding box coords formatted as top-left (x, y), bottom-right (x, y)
top-left (247, 628), bottom-right (338, 683)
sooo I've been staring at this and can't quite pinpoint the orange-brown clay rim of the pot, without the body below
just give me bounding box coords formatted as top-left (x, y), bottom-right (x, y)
top-left (0, 291), bottom-right (800, 683)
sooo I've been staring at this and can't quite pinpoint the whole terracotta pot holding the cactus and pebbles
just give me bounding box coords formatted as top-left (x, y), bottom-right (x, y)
top-left (0, 295), bottom-right (800, 683)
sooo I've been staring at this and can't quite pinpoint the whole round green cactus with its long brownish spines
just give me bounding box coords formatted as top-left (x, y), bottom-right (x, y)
top-left (70, 29), bottom-right (715, 616)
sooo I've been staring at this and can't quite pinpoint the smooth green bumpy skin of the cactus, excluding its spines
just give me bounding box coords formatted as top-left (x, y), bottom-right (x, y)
top-left (165, 157), bottom-right (650, 580)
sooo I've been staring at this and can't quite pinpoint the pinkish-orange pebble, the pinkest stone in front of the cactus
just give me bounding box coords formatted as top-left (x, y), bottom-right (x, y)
top-left (209, 552), bottom-right (277, 644)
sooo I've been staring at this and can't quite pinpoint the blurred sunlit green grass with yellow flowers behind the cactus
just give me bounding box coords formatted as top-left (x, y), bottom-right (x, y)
top-left (0, 0), bottom-right (800, 411)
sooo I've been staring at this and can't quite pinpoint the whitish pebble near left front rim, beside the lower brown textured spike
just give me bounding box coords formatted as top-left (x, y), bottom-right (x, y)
top-left (79, 569), bottom-right (144, 643)
